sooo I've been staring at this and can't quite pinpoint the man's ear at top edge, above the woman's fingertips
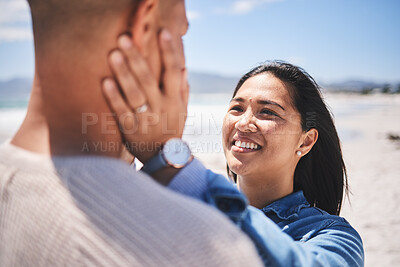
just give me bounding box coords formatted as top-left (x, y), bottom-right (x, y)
top-left (129, 0), bottom-right (159, 54)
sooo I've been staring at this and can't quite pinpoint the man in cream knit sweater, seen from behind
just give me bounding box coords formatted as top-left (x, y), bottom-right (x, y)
top-left (0, 0), bottom-right (260, 266)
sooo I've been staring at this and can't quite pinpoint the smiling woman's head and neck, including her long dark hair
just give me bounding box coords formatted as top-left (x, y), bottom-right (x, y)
top-left (223, 61), bottom-right (347, 215)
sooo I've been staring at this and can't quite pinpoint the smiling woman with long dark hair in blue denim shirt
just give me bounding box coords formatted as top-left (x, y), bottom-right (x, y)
top-left (105, 34), bottom-right (364, 266)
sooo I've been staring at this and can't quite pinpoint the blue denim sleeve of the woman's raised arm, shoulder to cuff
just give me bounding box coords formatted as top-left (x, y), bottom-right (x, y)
top-left (169, 160), bottom-right (364, 267)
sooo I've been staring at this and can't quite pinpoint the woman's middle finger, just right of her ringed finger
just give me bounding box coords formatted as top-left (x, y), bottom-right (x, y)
top-left (118, 35), bottom-right (161, 108)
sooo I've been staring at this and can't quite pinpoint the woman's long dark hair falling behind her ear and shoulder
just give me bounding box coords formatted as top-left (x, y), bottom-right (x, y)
top-left (228, 61), bottom-right (348, 215)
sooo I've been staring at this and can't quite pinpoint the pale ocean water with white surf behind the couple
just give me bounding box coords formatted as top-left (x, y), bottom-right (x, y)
top-left (0, 94), bottom-right (383, 147)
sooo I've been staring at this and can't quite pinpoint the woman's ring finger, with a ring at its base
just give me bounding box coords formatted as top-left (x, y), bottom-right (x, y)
top-left (110, 50), bottom-right (146, 108)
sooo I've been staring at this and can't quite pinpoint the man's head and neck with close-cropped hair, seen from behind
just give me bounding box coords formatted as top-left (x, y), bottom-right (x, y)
top-left (22, 0), bottom-right (188, 157)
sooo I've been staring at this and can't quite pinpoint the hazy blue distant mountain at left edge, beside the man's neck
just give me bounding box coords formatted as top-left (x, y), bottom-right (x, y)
top-left (0, 78), bottom-right (32, 101)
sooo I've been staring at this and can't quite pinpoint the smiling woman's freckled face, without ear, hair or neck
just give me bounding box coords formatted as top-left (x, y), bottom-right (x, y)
top-left (222, 73), bottom-right (303, 182)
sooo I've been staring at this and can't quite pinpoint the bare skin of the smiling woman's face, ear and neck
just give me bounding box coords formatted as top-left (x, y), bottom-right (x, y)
top-left (222, 73), bottom-right (318, 208)
